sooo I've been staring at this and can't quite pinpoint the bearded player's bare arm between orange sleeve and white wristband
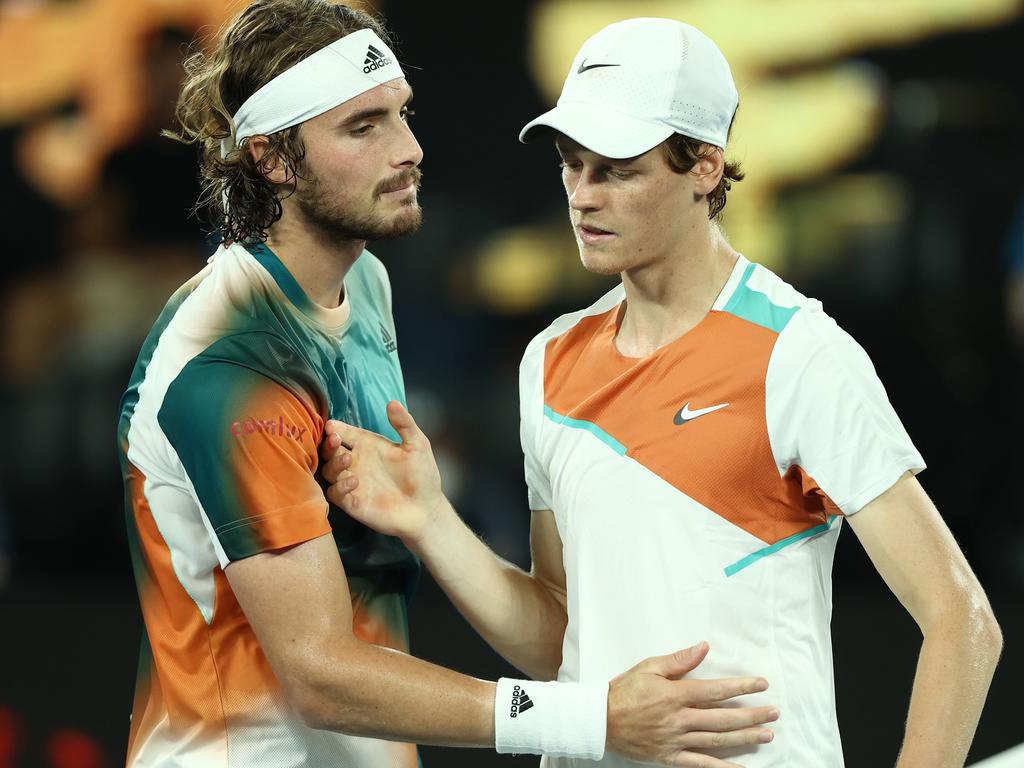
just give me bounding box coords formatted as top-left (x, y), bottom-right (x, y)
top-left (224, 536), bottom-right (495, 746)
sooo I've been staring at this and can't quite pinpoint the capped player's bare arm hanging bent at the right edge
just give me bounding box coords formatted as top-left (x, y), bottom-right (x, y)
top-left (848, 474), bottom-right (1002, 768)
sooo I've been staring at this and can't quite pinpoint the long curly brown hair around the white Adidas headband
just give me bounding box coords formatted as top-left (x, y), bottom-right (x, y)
top-left (163, 0), bottom-right (390, 241)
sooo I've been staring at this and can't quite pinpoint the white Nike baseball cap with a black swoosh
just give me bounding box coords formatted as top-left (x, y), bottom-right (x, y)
top-left (519, 18), bottom-right (739, 159)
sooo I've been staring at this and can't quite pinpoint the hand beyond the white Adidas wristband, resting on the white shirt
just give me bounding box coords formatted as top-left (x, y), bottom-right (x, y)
top-left (606, 643), bottom-right (778, 768)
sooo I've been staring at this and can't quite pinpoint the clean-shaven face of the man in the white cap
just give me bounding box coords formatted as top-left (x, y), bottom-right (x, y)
top-left (555, 135), bottom-right (707, 274)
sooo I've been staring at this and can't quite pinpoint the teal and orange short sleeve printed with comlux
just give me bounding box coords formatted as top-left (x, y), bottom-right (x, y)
top-left (158, 356), bottom-right (331, 565)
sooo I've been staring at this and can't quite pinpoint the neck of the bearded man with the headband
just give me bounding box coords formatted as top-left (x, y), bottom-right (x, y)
top-left (266, 213), bottom-right (367, 309)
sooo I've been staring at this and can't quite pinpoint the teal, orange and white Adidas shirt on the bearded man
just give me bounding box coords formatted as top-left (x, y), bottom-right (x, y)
top-left (113, 244), bottom-right (419, 768)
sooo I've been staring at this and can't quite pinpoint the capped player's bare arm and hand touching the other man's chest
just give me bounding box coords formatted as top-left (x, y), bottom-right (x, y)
top-left (322, 403), bottom-right (566, 680)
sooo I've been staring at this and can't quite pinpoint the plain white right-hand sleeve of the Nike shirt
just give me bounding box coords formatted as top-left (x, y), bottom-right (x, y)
top-left (765, 308), bottom-right (925, 515)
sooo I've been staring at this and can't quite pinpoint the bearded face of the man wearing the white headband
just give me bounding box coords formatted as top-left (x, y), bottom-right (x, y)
top-left (293, 78), bottom-right (423, 240)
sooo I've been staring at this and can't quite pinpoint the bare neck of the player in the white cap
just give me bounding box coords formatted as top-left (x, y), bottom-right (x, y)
top-left (615, 222), bottom-right (738, 357)
